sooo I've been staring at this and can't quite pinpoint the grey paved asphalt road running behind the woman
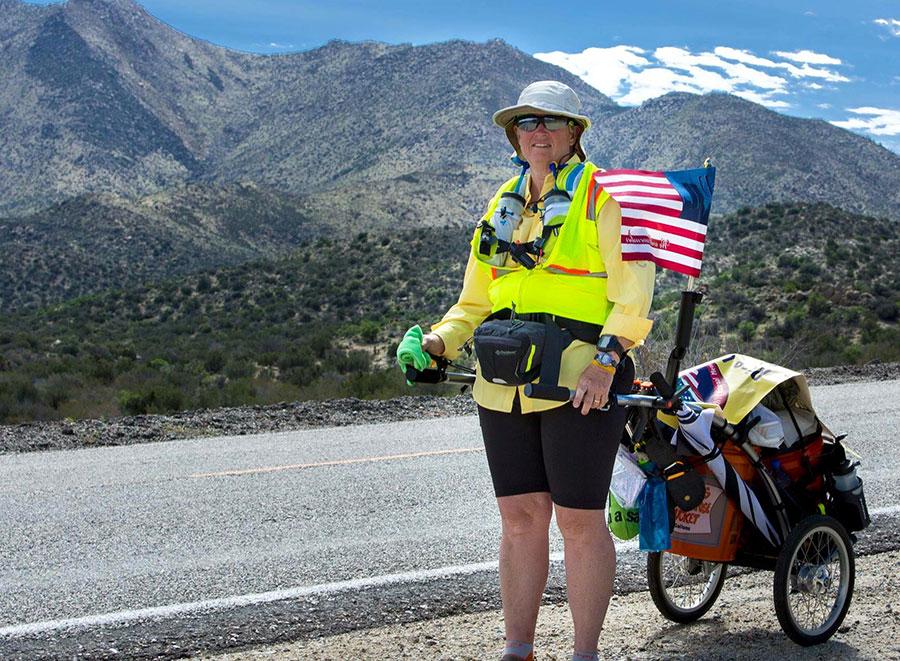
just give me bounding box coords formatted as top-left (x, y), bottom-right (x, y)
top-left (0, 381), bottom-right (900, 658)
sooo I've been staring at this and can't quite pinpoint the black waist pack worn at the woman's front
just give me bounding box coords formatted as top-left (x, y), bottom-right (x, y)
top-left (475, 319), bottom-right (547, 386)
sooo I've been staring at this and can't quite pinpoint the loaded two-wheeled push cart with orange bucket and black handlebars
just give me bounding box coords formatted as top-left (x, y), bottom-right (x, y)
top-left (407, 340), bottom-right (869, 645)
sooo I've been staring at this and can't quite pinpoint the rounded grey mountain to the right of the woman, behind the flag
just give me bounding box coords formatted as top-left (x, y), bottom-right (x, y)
top-left (588, 93), bottom-right (900, 219)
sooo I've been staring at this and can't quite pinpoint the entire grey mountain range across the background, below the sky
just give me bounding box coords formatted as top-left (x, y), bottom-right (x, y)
top-left (0, 0), bottom-right (900, 226)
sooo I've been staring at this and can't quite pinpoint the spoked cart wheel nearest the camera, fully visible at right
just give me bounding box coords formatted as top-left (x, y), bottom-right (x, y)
top-left (774, 515), bottom-right (856, 645)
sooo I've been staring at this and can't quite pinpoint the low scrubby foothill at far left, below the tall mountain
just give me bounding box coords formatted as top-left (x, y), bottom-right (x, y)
top-left (0, 184), bottom-right (324, 310)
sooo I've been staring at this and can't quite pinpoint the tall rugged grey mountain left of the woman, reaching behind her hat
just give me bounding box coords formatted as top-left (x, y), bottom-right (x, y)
top-left (0, 0), bottom-right (616, 214)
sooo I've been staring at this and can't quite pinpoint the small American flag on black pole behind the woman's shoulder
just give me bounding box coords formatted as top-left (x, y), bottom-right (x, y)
top-left (590, 167), bottom-right (716, 277)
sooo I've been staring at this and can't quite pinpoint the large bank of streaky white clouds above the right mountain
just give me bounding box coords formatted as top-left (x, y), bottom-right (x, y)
top-left (534, 45), bottom-right (849, 108)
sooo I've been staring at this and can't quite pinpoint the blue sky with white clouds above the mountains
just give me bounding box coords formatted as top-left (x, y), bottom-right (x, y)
top-left (22, 0), bottom-right (900, 153)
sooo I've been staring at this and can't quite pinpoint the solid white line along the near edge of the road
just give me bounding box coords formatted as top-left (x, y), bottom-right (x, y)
top-left (0, 505), bottom-right (900, 638)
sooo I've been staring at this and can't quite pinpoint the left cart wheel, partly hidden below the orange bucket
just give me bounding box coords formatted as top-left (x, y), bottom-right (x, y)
top-left (647, 551), bottom-right (728, 624)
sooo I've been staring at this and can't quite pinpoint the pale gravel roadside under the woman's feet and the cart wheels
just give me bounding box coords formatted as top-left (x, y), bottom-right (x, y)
top-left (204, 550), bottom-right (900, 661)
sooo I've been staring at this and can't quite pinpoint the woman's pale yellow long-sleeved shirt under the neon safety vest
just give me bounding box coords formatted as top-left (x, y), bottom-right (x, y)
top-left (431, 156), bottom-right (656, 413)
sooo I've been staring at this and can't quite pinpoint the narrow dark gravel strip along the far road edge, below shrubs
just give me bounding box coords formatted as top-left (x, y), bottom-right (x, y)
top-left (0, 363), bottom-right (900, 454)
